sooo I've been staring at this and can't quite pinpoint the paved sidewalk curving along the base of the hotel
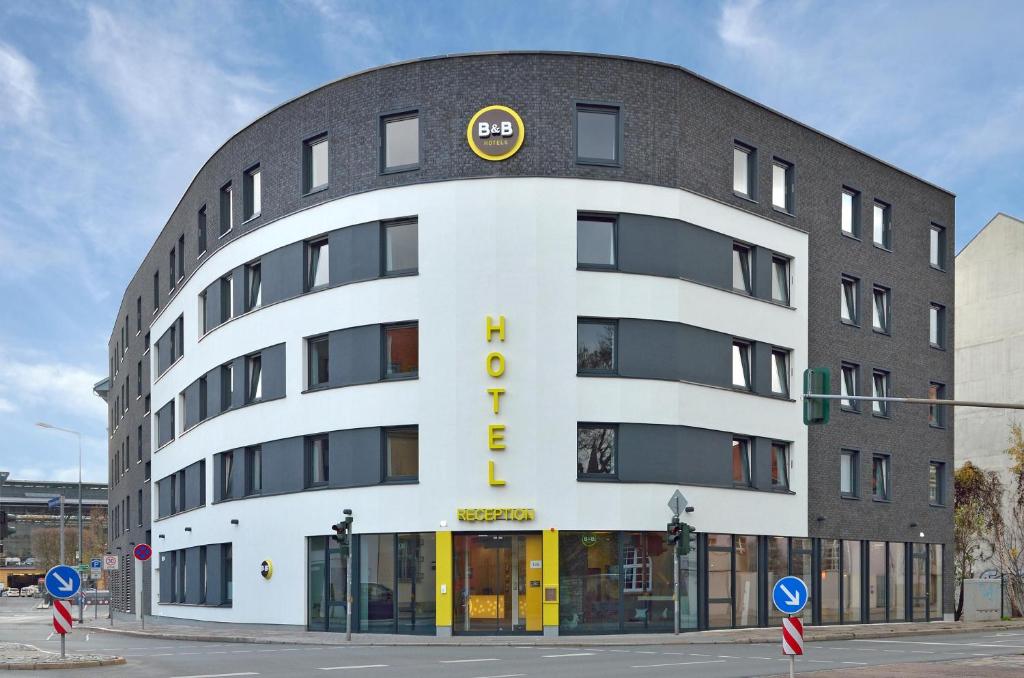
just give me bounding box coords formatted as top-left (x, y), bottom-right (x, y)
top-left (79, 618), bottom-right (1024, 647)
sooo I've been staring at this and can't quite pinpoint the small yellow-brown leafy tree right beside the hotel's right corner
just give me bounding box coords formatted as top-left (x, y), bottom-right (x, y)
top-left (953, 462), bottom-right (1002, 619)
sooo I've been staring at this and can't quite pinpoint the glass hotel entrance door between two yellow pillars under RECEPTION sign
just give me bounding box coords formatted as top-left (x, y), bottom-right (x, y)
top-left (453, 533), bottom-right (543, 634)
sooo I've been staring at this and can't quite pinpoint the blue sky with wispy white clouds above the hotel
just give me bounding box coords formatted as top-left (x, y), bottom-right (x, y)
top-left (0, 0), bottom-right (1024, 480)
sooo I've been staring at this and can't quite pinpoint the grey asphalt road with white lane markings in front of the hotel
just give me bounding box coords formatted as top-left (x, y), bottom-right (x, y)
top-left (0, 601), bottom-right (1024, 678)
